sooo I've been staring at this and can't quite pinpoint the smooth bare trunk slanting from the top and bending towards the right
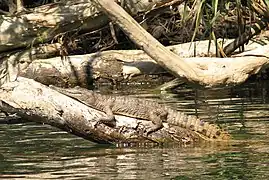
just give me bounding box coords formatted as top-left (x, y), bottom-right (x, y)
top-left (92, 0), bottom-right (267, 86)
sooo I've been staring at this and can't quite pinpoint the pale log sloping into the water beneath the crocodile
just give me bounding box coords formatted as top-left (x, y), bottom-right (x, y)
top-left (0, 78), bottom-right (205, 144)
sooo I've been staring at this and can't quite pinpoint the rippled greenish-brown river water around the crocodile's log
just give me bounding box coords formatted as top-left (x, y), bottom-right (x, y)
top-left (0, 82), bottom-right (269, 179)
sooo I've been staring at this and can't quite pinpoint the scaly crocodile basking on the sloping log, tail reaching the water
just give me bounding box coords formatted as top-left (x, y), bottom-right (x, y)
top-left (50, 85), bottom-right (230, 141)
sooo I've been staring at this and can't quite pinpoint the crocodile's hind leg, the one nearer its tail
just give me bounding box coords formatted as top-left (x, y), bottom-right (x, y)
top-left (147, 111), bottom-right (168, 135)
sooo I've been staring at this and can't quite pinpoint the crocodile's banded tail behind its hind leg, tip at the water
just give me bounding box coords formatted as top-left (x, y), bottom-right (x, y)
top-left (167, 109), bottom-right (230, 140)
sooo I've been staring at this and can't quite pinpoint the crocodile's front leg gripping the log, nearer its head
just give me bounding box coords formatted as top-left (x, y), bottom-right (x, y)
top-left (95, 104), bottom-right (116, 127)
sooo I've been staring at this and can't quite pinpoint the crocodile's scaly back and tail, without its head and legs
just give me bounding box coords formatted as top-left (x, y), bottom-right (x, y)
top-left (95, 93), bottom-right (230, 140)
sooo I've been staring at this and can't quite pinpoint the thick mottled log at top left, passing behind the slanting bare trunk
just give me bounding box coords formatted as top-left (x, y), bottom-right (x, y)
top-left (0, 0), bottom-right (178, 53)
